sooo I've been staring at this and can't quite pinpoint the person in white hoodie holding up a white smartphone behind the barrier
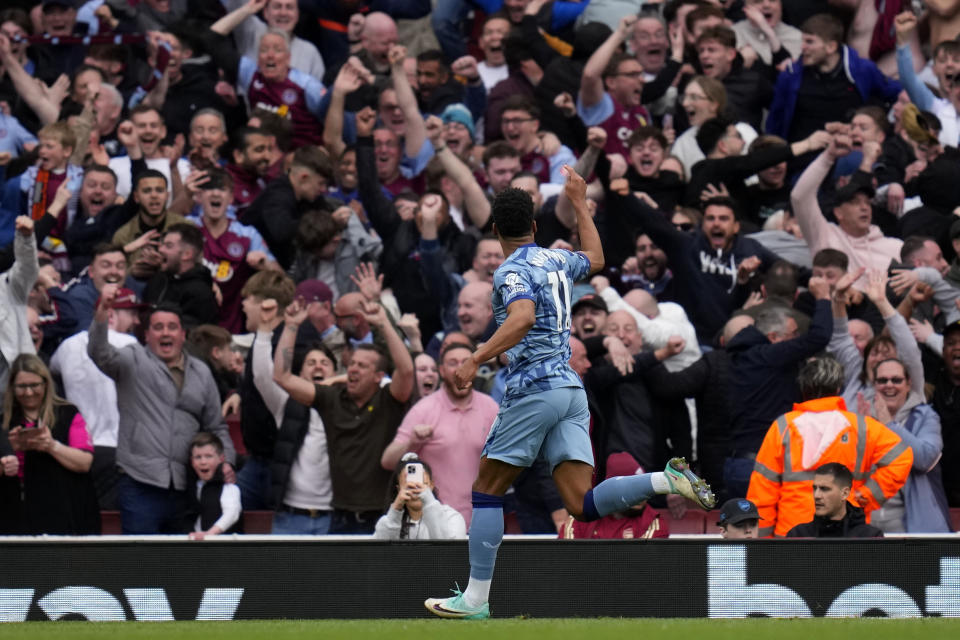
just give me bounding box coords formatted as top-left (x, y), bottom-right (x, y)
top-left (373, 453), bottom-right (467, 540)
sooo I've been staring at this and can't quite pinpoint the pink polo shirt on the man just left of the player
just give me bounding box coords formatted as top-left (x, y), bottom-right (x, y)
top-left (396, 387), bottom-right (499, 528)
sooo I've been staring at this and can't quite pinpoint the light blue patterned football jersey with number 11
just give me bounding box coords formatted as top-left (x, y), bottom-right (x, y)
top-left (493, 244), bottom-right (590, 399)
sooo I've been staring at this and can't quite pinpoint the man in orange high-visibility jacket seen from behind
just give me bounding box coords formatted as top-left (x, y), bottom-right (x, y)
top-left (747, 356), bottom-right (913, 536)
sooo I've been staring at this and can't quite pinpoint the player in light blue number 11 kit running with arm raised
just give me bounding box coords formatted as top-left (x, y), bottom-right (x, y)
top-left (424, 166), bottom-right (715, 619)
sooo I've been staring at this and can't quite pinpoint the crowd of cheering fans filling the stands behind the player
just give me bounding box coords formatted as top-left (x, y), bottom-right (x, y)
top-left (0, 0), bottom-right (960, 538)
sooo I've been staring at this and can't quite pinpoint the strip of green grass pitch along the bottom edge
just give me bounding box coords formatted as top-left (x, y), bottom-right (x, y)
top-left (0, 618), bottom-right (960, 640)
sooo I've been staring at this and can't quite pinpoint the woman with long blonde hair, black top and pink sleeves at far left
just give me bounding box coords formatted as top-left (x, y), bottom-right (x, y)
top-left (2, 354), bottom-right (100, 535)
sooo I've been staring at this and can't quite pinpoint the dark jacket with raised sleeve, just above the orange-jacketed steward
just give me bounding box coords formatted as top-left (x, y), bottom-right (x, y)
top-left (727, 300), bottom-right (833, 453)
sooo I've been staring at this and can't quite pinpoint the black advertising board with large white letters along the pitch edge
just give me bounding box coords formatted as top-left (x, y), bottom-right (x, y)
top-left (0, 536), bottom-right (960, 621)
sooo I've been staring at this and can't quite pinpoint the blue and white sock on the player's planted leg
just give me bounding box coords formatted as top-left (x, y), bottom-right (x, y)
top-left (463, 491), bottom-right (503, 607)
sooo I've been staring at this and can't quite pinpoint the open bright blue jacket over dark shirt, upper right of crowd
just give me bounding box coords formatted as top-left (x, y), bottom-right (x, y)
top-left (767, 45), bottom-right (902, 139)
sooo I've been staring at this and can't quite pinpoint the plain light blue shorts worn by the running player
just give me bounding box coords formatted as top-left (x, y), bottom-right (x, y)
top-left (483, 387), bottom-right (593, 471)
